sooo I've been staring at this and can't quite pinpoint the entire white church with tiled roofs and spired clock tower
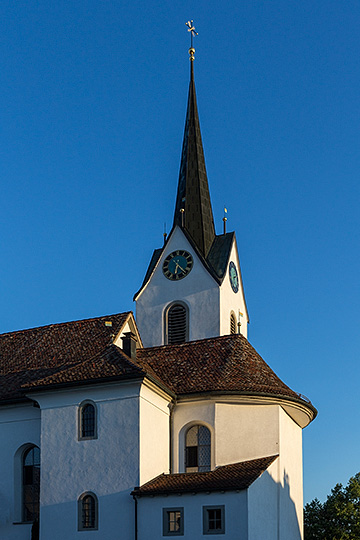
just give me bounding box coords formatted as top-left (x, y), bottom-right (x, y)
top-left (0, 43), bottom-right (317, 540)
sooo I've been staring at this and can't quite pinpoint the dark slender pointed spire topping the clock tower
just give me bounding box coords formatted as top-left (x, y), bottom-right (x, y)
top-left (174, 56), bottom-right (215, 257)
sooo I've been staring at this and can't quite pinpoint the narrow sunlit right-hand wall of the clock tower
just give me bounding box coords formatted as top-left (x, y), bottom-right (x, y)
top-left (220, 236), bottom-right (248, 337)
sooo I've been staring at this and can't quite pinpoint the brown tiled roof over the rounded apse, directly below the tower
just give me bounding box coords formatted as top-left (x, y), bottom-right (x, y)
top-left (138, 334), bottom-right (300, 400)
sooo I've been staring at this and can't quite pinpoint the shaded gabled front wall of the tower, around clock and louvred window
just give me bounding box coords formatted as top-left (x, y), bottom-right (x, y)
top-left (136, 227), bottom-right (220, 347)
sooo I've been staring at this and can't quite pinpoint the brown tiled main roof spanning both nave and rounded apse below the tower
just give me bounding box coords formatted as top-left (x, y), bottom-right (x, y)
top-left (0, 313), bottom-right (316, 413)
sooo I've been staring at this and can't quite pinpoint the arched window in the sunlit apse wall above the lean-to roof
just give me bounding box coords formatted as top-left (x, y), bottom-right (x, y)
top-left (185, 426), bottom-right (211, 472)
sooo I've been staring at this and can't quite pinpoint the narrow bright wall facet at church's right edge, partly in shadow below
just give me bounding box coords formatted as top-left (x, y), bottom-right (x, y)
top-left (279, 409), bottom-right (303, 540)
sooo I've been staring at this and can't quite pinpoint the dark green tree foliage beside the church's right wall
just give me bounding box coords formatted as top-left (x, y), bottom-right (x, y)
top-left (304, 473), bottom-right (360, 540)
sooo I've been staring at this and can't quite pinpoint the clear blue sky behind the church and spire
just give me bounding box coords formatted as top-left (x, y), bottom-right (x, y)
top-left (0, 0), bottom-right (360, 501)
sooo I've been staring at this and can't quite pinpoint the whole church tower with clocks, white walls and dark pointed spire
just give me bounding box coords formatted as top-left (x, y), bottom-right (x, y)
top-left (134, 47), bottom-right (249, 347)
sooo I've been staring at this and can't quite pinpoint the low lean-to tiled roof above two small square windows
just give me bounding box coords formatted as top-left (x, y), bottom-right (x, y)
top-left (133, 455), bottom-right (278, 496)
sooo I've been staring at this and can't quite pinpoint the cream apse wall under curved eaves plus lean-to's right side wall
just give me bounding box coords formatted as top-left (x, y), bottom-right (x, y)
top-left (173, 396), bottom-right (303, 540)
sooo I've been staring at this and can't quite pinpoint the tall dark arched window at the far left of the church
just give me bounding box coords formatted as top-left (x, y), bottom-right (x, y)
top-left (22, 446), bottom-right (40, 521)
